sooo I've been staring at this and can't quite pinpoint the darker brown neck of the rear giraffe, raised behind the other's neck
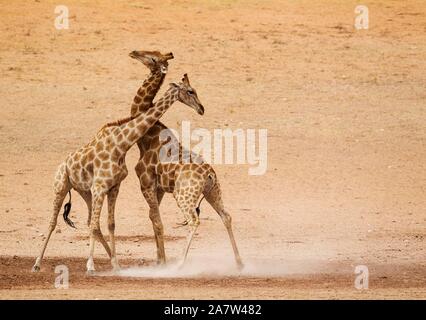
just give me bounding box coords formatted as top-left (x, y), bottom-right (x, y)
top-left (130, 69), bottom-right (166, 117)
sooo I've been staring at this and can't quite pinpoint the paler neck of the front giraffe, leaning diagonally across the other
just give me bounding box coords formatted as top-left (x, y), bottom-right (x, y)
top-left (120, 87), bottom-right (179, 152)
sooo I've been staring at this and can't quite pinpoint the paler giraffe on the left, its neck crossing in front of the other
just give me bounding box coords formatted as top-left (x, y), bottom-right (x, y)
top-left (33, 71), bottom-right (204, 274)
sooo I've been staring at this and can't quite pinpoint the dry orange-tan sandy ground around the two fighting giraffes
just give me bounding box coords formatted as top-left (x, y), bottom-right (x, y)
top-left (0, 0), bottom-right (426, 299)
